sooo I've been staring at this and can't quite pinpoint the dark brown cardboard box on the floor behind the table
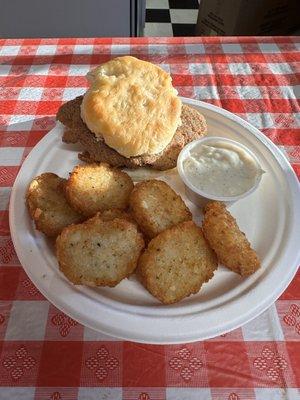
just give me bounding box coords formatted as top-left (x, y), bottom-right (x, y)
top-left (196, 0), bottom-right (300, 36)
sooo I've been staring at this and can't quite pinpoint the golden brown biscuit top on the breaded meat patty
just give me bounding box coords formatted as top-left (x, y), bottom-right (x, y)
top-left (81, 56), bottom-right (181, 157)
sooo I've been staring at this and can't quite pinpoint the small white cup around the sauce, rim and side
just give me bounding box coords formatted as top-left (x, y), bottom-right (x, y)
top-left (177, 136), bottom-right (262, 207)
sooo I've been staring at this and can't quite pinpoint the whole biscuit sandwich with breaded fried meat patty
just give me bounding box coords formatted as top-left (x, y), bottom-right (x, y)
top-left (57, 56), bottom-right (207, 170)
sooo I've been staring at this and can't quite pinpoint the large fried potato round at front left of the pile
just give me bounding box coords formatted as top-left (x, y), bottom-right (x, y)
top-left (56, 217), bottom-right (144, 287)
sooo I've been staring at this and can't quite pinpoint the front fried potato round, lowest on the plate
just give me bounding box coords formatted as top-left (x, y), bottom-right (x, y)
top-left (137, 221), bottom-right (218, 304)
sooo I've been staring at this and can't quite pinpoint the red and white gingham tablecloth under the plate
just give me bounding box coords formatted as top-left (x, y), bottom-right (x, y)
top-left (0, 37), bottom-right (300, 400)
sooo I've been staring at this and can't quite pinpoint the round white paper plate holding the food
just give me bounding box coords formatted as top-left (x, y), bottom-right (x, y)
top-left (9, 99), bottom-right (300, 344)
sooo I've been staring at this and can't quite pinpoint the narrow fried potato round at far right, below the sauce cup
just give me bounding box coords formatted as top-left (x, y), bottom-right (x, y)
top-left (202, 201), bottom-right (260, 276)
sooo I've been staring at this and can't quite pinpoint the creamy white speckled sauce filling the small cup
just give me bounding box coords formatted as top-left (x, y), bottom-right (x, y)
top-left (182, 140), bottom-right (264, 197)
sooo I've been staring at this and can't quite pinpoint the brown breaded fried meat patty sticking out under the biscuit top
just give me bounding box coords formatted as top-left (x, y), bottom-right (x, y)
top-left (57, 96), bottom-right (207, 170)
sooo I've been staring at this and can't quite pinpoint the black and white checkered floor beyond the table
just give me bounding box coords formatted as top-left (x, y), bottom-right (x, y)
top-left (144, 0), bottom-right (199, 36)
